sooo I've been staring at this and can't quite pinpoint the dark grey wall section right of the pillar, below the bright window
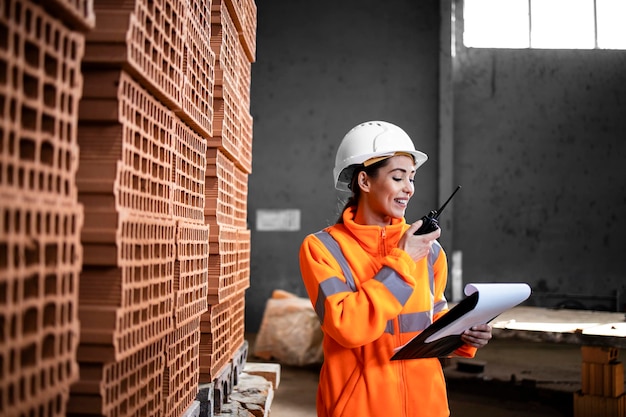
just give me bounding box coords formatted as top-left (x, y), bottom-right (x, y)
top-left (454, 49), bottom-right (626, 311)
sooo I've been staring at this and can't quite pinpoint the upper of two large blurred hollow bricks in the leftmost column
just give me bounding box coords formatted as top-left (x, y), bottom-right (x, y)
top-left (0, 0), bottom-right (84, 204)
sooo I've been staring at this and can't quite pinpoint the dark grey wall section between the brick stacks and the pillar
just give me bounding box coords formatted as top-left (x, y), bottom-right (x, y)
top-left (246, 0), bottom-right (439, 331)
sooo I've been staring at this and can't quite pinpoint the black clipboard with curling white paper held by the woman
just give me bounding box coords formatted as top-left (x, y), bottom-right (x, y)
top-left (391, 283), bottom-right (531, 360)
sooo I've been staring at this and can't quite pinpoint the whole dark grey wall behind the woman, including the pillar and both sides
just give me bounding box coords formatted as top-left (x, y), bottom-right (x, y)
top-left (246, 0), bottom-right (626, 332)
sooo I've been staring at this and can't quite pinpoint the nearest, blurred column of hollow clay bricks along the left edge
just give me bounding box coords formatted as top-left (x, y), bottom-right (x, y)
top-left (0, 0), bottom-right (94, 417)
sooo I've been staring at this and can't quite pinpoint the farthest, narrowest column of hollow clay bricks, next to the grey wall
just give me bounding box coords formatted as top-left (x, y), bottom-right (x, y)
top-left (200, 0), bottom-right (256, 410)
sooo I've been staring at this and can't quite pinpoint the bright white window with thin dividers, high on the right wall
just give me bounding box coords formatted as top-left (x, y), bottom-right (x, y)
top-left (463, 0), bottom-right (626, 49)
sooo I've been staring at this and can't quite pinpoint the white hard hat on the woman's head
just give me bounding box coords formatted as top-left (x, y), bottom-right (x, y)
top-left (333, 121), bottom-right (428, 191)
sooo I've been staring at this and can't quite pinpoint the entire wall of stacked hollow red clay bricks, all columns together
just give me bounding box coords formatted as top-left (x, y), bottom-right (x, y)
top-left (0, 0), bottom-right (256, 417)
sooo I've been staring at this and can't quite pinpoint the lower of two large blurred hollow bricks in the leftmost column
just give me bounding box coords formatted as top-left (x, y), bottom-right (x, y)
top-left (0, 195), bottom-right (82, 416)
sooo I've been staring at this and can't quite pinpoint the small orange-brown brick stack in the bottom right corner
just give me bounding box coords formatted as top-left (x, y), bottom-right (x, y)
top-left (574, 346), bottom-right (626, 417)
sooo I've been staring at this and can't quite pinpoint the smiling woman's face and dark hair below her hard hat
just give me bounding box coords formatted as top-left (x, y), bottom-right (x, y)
top-left (355, 155), bottom-right (415, 226)
